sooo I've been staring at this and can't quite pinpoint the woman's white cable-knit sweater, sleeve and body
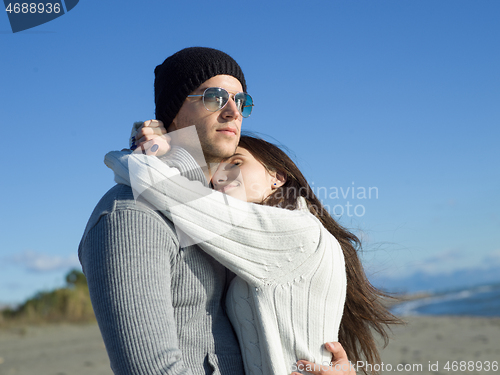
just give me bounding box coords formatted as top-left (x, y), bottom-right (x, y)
top-left (105, 152), bottom-right (346, 375)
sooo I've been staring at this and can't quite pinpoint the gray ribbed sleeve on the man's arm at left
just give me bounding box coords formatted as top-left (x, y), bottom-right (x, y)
top-left (80, 209), bottom-right (192, 375)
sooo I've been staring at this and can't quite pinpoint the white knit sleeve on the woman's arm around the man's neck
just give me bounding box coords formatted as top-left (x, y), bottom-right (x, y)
top-left (106, 152), bottom-right (321, 285)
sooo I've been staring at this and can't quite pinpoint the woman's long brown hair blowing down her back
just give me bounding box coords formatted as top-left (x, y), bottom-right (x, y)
top-left (239, 135), bottom-right (402, 374)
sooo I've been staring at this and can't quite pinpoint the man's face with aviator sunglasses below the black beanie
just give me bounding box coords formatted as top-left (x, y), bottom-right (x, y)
top-left (168, 75), bottom-right (243, 163)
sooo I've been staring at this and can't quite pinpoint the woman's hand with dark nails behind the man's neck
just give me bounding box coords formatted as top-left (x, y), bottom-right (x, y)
top-left (131, 120), bottom-right (170, 156)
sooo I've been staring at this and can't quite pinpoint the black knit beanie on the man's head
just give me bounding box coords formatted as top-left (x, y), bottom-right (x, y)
top-left (155, 47), bottom-right (247, 128)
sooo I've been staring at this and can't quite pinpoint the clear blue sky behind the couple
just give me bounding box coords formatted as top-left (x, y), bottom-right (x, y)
top-left (0, 0), bottom-right (500, 303)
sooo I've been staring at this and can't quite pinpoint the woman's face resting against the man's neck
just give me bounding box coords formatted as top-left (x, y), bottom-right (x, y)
top-left (212, 147), bottom-right (282, 203)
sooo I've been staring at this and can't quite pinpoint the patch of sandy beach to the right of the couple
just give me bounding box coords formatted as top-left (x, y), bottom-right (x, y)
top-left (381, 316), bottom-right (500, 374)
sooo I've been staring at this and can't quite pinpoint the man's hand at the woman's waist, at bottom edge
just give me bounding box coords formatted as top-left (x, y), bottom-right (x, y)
top-left (292, 342), bottom-right (356, 375)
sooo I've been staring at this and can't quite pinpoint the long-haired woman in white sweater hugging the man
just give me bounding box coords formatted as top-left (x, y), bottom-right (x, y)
top-left (106, 122), bottom-right (397, 375)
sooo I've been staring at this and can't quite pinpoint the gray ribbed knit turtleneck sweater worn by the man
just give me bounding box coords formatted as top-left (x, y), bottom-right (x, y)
top-left (78, 149), bottom-right (244, 375)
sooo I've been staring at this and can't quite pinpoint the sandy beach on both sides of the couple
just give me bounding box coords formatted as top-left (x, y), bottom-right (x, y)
top-left (0, 316), bottom-right (500, 375)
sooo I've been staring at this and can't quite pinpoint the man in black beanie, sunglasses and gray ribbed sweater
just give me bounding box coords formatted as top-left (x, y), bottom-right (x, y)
top-left (78, 47), bottom-right (250, 375)
